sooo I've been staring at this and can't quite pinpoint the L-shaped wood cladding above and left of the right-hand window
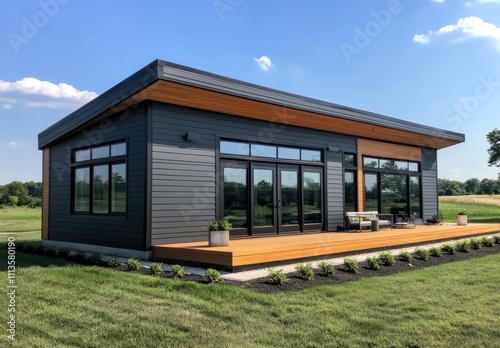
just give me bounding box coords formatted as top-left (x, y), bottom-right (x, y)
top-left (358, 139), bottom-right (422, 211)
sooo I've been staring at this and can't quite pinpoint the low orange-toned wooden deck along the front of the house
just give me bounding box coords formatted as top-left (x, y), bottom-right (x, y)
top-left (153, 223), bottom-right (500, 271)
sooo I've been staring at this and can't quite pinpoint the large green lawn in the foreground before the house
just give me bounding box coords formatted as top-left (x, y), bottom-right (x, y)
top-left (0, 249), bottom-right (500, 348)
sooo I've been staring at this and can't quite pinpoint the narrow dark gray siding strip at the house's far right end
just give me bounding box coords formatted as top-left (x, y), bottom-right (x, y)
top-left (422, 148), bottom-right (439, 221)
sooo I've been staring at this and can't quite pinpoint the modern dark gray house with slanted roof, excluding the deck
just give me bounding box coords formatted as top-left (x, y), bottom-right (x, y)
top-left (39, 60), bottom-right (464, 255)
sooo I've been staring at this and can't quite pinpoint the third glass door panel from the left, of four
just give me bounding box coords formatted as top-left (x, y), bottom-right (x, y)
top-left (278, 167), bottom-right (300, 232)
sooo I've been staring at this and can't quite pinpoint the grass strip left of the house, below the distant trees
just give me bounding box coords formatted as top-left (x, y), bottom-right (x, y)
top-left (0, 206), bottom-right (42, 233)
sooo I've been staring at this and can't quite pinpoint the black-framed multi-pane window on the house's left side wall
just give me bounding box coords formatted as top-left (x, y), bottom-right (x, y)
top-left (72, 142), bottom-right (127, 214)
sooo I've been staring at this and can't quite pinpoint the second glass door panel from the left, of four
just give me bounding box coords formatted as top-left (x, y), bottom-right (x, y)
top-left (252, 165), bottom-right (277, 234)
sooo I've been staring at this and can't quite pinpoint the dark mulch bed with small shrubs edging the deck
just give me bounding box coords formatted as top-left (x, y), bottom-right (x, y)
top-left (115, 244), bottom-right (500, 293)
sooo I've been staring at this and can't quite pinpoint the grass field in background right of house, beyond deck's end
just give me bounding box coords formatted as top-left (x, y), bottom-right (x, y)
top-left (439, 195), bottom-right (500, 223)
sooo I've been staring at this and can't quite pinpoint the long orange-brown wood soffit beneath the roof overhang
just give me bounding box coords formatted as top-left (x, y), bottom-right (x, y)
top-left (89, 80), bottom-right (456, 149)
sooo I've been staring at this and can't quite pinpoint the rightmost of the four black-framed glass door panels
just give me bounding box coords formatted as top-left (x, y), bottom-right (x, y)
top-left (302, 169), bottom-right (323, 230)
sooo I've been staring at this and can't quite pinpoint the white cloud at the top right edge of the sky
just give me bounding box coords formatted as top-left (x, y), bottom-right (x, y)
top-left (413, 16), bottom-right (500, 50)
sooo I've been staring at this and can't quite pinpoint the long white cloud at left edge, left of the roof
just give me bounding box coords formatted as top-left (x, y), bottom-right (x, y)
top-left (0, 77), bottom-right (98, 109)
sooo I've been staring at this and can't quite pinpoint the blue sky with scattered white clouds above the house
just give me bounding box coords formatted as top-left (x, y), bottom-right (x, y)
top-left (0, 0), bottom-right (500, 185)
